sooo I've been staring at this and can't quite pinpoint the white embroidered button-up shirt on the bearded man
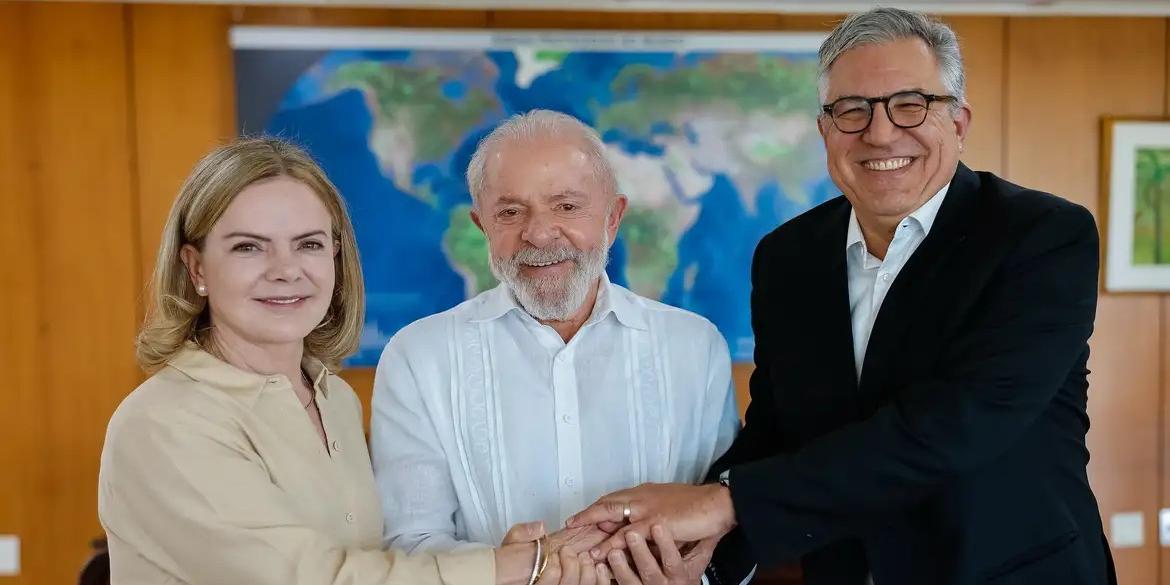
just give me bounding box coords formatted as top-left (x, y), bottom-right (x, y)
top-left (371, 277), bottom-right (739, 552)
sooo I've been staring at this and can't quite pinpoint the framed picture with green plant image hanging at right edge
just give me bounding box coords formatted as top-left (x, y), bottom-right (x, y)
top-left (1101, 118), bottom-right (1170, 293)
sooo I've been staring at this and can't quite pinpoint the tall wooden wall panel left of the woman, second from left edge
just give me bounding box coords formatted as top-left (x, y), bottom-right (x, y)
top-left (35, 5), bottom-right (140, 583)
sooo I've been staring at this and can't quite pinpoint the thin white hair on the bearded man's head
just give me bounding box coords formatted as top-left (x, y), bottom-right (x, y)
top-left (467, 110), bottom-right (618, 207)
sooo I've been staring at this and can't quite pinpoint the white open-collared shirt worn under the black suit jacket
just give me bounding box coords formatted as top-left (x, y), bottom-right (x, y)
top-left (845, 183), bottom-right (950, 379)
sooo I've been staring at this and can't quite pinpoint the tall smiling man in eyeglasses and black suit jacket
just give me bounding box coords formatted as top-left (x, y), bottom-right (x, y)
top-left (570, 8), bottom-right (1116, 585)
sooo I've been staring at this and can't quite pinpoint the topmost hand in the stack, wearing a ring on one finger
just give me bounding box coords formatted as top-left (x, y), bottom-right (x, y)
top-left (565, 483), bottom-right (736, 560)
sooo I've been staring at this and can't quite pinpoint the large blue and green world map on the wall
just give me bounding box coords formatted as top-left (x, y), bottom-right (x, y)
top-left (233, 29), bottom-right (838, 366)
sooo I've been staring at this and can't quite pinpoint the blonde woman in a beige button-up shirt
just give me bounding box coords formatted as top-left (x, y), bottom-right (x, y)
top-left (98, 139), bottom-right (604, 585)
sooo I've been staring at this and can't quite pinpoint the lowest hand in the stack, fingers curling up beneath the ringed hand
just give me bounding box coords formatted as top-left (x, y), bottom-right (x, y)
top-left (606, 525), bottom-right (720, 585)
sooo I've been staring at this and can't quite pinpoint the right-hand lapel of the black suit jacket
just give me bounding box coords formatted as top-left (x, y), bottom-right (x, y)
top-left (859, 163), bottom-right (979, 394)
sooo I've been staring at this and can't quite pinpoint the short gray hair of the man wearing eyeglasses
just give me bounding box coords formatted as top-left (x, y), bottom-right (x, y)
top-left (817, 8), bottom-right (966, 104)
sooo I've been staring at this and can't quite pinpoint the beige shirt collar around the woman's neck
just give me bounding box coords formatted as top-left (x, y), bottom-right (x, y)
top-left (167, 342), bottom-right (331, 406)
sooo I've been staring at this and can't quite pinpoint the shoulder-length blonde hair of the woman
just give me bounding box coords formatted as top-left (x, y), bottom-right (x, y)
top-left (137, 138), bottom-right (365, 372)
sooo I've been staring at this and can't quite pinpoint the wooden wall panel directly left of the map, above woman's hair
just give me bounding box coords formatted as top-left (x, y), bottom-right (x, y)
top-left (128, 5), bottom-right (235, 290)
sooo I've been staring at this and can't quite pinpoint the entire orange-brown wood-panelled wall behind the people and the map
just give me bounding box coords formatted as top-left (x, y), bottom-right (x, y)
top-left (0, 2), bottom-right (1170, 585)
